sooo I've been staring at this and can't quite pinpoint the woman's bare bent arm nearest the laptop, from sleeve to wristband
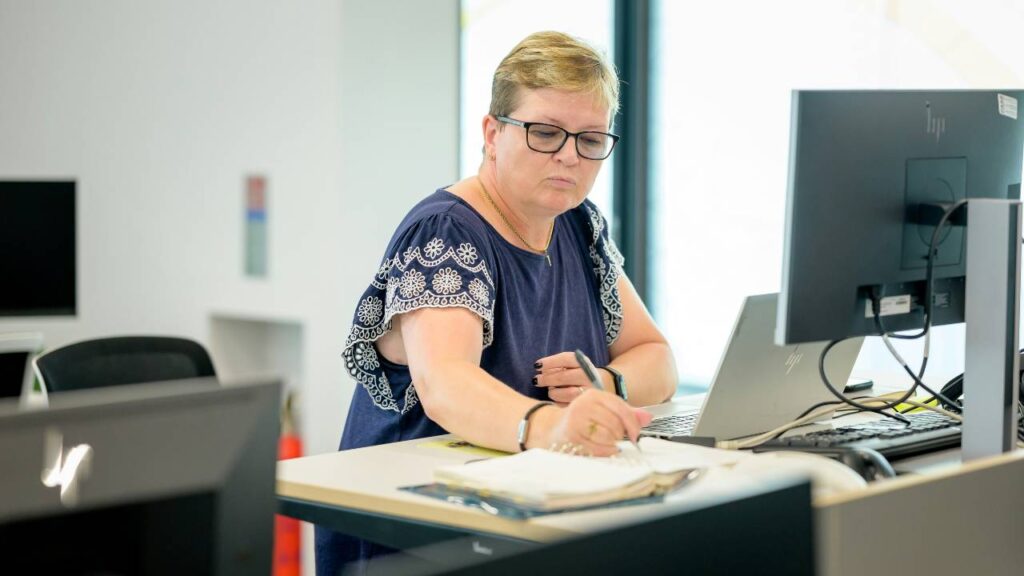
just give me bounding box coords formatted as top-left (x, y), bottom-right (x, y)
top-left (601, 274), bottom-right (679, 406)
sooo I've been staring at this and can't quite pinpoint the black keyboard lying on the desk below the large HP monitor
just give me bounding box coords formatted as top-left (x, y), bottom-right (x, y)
top-left (763, 412), bottom-right (961, 460)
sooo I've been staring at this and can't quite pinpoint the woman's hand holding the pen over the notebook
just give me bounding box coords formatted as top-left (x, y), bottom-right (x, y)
top-left (535, 388), bottom-right (652, 456)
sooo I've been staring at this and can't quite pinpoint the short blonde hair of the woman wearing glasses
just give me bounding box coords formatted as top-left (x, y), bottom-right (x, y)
top-left (489, 32), bottom-right (618, 120)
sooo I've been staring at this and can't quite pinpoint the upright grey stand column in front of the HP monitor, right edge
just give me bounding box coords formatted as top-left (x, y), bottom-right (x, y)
top-left (961, 199), bottom-right (1021, 461)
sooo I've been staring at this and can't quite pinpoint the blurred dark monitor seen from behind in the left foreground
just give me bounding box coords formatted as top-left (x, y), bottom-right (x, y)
top-left (0, 379), bottom-right (280, 575)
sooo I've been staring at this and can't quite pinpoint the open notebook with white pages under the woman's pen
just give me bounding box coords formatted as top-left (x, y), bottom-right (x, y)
top-left (434, 438), bottom-right (751, 511)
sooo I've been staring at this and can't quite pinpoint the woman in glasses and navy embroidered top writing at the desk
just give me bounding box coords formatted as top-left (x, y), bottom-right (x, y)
top-left (317, 32), bottom-right (676, 573)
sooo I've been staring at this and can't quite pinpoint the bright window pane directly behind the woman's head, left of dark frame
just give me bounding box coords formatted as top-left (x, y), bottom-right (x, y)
top-left (460, 0), bottom-right (612, 215)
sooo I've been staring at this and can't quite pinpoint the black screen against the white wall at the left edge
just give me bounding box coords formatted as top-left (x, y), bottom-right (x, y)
top-left (0, 180), bottom-right (77, 317)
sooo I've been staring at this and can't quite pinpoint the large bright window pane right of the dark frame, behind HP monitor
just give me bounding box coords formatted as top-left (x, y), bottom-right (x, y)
top-left (647, 0), bottom-right (1024, 386)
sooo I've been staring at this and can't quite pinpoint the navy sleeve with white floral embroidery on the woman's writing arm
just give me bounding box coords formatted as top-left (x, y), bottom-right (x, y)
top-left (343, 213), bottom-right (495, 413)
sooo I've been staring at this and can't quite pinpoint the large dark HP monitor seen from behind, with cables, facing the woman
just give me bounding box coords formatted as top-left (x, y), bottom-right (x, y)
top-left (775, 90), bottom-right (1024, 344)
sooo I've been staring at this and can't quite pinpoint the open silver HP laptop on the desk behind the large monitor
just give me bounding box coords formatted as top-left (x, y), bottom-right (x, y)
top-left (641, 294), bottom-right (863, 440)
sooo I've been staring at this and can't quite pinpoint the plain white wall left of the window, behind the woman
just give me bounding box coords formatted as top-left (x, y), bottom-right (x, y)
top-left (0, 0), bottom-right (459, 453)
